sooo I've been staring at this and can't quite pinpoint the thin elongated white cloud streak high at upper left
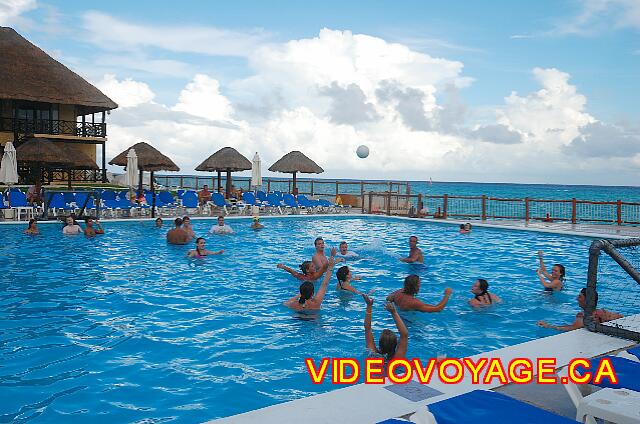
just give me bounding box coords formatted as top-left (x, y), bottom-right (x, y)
top-left (82, 11), bottom-right (269, 56)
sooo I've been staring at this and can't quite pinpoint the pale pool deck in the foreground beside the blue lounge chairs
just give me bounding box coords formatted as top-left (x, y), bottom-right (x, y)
top-left (210, 328), bottom-right (637, 424)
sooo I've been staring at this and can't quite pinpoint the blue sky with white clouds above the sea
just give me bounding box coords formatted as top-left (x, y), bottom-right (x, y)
top-left (0, 0), bottom-right (640, 185)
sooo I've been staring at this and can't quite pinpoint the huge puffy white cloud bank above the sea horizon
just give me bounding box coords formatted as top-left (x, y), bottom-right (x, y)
top-left (99, 30), bottom-right (637, 183)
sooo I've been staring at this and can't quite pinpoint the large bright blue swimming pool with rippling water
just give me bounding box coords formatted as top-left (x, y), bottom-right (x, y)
top-left (0, 217), bottom-right (625, 423)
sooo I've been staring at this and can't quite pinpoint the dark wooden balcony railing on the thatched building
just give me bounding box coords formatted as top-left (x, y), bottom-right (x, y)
top-left (0, 118), bottom-right (107, 137)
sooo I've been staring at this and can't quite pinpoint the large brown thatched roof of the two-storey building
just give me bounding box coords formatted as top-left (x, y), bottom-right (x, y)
top-left (0, 27), bottom-right (118, 114)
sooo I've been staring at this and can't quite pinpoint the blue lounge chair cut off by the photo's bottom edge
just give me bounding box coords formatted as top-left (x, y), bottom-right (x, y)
top-left (381, 390), bottom-right (576, 424)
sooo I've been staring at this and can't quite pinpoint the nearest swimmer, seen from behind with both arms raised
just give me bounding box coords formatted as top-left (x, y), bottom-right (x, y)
top-left (362, 294), bottom-right (409, 362)
